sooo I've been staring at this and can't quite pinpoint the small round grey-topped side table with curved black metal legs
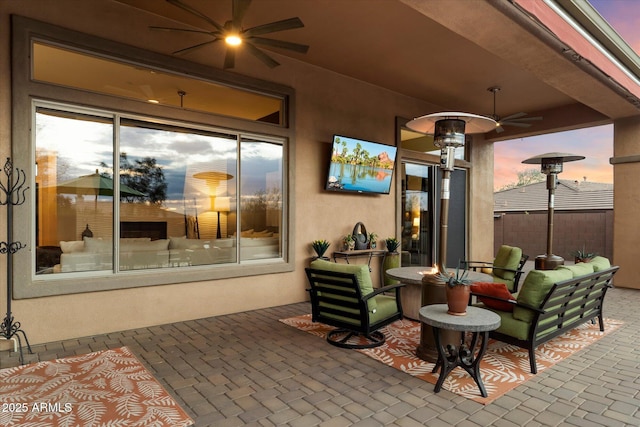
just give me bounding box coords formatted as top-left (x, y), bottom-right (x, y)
top-left (420, 304), bottom-right (500, 397)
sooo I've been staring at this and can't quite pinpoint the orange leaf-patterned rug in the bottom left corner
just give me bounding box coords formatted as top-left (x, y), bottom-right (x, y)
top-left (0, 347), bottom-right (193, 427)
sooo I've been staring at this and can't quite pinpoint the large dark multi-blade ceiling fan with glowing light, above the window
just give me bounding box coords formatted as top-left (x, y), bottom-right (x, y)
top-left (149, 0), bottom-right (309, 69)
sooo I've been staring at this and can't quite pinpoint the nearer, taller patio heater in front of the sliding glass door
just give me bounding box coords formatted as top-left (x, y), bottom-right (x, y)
top-left (407, 112), bottom-right (497, 362)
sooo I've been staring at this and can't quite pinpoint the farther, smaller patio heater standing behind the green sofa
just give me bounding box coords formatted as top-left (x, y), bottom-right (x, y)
top-left (522, 153), bottom-right (584, 270)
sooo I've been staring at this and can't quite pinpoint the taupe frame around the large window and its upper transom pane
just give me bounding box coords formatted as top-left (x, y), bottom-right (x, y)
top-left (12, 16), bottom-right (295, 299)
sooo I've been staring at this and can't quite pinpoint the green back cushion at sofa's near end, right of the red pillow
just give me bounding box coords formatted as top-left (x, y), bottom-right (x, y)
top-left (513, 269), bottom-right (573, 322)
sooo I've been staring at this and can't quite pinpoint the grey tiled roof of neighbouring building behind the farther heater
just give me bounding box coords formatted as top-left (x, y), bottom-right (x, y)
top-left (493, 179), bottom-right (613, 212)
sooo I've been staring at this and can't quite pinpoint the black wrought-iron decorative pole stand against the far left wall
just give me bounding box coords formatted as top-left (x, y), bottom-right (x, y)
top-left (0, 157), bottom-right (32, 364)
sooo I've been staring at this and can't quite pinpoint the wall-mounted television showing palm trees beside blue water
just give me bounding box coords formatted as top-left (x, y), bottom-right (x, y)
top-left (325, 135), bottom-right (397, 194)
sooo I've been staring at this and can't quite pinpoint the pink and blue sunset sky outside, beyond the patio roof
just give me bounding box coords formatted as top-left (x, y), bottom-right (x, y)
top-left (493, 0), bottom-right (640, 190)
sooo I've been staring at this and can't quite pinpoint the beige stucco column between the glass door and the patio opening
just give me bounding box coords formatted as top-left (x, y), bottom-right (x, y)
top-left (468, 134), bottom-right (494, 261)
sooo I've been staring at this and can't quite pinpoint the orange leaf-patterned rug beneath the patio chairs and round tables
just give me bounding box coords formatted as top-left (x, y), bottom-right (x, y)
top-left (280, 314), bottom-right (623, 404)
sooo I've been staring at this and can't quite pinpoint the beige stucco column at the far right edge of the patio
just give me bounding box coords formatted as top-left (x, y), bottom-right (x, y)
top-left (611, 117), bottom-right (640, 289)
